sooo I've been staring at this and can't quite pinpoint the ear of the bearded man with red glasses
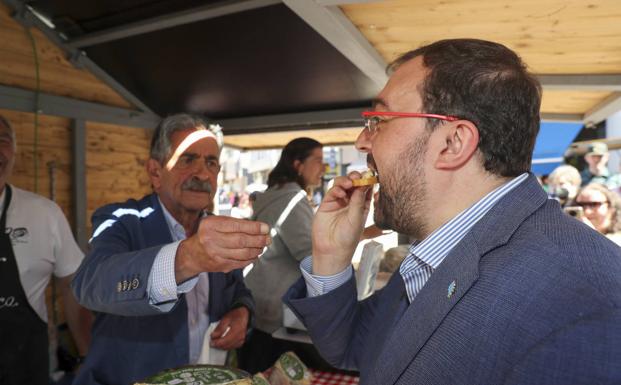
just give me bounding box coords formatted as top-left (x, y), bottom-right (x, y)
top-left (435, 120), bottom-right (479, 170)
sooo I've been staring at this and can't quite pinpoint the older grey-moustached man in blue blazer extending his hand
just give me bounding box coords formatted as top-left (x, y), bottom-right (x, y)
top-left (72, 114), bottom-right (270, 385)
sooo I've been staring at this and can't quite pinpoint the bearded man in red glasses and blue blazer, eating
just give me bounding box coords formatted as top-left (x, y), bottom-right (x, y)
top-left (285, 39), bottom-right (621, 385)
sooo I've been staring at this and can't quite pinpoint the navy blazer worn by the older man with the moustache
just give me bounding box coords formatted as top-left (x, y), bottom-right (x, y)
top-left (72, 194), bottom-right (254, 385)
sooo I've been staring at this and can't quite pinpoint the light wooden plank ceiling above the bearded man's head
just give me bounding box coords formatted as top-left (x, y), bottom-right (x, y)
top-left (342, 0), bottom-right (621, 114)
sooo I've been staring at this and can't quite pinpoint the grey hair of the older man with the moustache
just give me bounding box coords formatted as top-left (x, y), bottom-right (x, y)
top-left (149, 114), bottom-right (222, 164)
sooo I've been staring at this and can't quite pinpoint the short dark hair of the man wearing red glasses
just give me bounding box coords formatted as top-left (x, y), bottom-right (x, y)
top-left (389, 39), bottom-right (541, 177)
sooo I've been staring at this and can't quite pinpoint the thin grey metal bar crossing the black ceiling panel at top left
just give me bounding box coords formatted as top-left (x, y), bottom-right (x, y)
top-left (67, 0), bottom-right (281, 48)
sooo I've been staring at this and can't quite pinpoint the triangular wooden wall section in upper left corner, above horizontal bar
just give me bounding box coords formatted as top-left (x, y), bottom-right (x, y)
top-left (0, 3), bottom-right (132, 108)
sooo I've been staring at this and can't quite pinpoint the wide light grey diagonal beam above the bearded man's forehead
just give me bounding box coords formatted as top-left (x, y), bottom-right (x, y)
top-left (283, 0), bottom-right (388, 91)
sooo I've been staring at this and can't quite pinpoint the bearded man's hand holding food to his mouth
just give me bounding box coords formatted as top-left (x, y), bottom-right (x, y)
top-left (312, 172), bottom-right (372, 275)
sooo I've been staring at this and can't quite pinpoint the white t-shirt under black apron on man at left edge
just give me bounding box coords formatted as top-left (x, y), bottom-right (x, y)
top-left (0, 186), bottom-right (84, 322)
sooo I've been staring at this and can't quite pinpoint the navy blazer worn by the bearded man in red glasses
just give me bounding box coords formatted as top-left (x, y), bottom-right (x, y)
top-left (284, 175), bottom-right (621, 385)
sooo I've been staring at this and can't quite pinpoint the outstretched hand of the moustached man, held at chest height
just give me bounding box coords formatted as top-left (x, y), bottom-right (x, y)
top-left (175, 216), bottom-right (271, 284)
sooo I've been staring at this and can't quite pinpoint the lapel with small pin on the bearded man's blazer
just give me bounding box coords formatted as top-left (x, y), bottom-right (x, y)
top-left (371, 175), bottom-right (547, 384)
